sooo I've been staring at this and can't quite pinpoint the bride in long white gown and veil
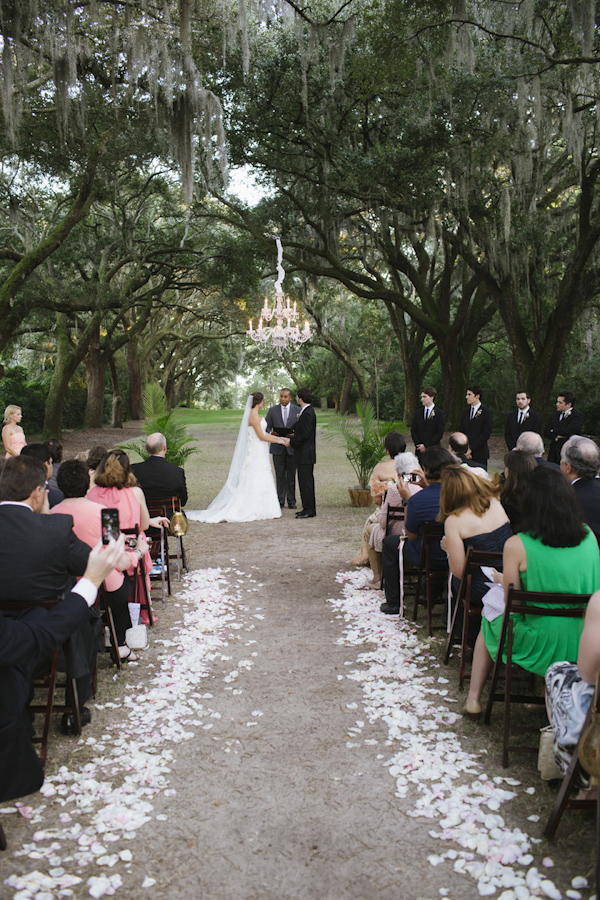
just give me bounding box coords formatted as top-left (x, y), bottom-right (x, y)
top-left (186, 391), bottom-right (290, 523)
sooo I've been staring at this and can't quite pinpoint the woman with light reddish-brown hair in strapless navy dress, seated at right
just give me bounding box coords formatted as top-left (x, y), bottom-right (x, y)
top-left (438, 466), bottom-right (512, 645)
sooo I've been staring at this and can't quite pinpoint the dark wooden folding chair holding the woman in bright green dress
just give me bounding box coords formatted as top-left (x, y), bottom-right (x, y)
top-left (485, 584), bottom-right (591, 768)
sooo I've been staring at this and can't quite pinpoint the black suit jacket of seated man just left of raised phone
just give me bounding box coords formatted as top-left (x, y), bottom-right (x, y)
top-left (0, 504), bottom-right (90, 604)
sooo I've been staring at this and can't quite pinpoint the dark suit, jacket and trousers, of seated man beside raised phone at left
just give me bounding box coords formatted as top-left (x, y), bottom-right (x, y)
top-left (0, 503), bottom-right (96, 706)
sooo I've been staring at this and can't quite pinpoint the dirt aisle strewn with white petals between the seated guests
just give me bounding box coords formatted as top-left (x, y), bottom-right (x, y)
top-left (0, 424), bottom-right (592, 900)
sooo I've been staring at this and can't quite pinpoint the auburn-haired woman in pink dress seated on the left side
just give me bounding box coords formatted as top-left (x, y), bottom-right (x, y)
top-left (88, 450), bottom-right (169, 625)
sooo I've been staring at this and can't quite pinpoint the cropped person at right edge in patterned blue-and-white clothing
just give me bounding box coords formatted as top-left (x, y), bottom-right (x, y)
top-left (546, 592), bottom-right (600, 788)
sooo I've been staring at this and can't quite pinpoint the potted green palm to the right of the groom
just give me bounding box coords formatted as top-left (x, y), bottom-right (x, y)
top-left (340, 400), bottom-right (402, 506)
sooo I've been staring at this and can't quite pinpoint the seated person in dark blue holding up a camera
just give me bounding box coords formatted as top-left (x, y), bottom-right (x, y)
top-left (380, 447), bottom-right (456, 615)
